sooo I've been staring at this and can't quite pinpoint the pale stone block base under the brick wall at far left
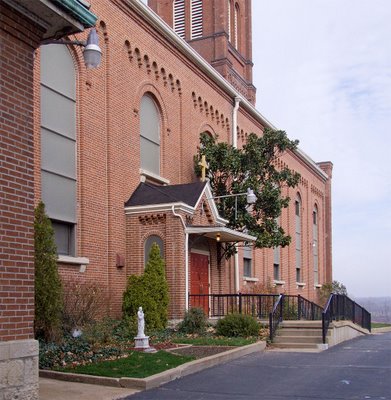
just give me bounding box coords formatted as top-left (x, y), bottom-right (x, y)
top-left (0, 340), bottom-right (39, 400)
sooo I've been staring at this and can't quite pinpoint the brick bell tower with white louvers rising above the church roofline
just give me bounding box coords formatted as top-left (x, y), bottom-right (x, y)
top-left (148, 0), bottom-right (256, 104)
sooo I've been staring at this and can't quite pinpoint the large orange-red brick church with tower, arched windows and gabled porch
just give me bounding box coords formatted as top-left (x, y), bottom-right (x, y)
top-left (34, 0), bottom-right (332, 319)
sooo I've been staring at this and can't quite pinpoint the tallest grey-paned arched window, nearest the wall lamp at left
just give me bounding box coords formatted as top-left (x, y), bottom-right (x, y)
top-left (41, 45), bottom-right (77, 256)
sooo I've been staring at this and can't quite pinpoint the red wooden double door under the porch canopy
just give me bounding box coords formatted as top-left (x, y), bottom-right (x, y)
top-left (190, 253), bottom-right (209, 316)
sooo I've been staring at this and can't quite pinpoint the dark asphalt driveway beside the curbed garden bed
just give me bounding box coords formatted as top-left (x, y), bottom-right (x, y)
top-left (126, 332), bottom-right (391, 400)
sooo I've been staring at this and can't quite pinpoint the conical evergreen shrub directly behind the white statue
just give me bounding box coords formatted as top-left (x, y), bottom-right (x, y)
top-left (122, 243), bottom-right (169, 331)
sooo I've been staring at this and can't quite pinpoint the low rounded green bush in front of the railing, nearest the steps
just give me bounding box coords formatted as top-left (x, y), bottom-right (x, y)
top-left (216, 314), bottom-right (260, 337)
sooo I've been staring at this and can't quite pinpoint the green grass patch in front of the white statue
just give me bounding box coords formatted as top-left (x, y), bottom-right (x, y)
top-left (58, 351), bottom-right (195, 378)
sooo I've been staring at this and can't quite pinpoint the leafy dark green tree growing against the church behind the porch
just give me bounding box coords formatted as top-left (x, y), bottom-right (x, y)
top-left (194, 128), bottom-right (300, 257)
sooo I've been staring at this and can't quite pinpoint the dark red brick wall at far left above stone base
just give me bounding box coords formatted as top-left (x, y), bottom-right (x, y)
top-left (0, 4), bottom-right (42, 341)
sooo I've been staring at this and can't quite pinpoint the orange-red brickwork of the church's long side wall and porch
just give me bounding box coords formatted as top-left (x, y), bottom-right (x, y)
top-left (35, 0), bottom-right (334, 317)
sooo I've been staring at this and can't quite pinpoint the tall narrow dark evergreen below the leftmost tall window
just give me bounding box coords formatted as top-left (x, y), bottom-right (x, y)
top-left (34, 202), bottom-right (63, 341)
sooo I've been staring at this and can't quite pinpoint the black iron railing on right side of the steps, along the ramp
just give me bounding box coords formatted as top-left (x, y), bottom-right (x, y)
top-left (322, 293), bottom-right (371, 343)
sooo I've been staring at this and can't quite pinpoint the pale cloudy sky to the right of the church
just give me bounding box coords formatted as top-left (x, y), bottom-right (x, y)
top-left (252, 0), bottom-right (391, 297)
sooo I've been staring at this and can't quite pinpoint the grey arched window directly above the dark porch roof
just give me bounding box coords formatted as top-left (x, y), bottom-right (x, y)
top-left (140, 94), bottom-right (160, 175)
